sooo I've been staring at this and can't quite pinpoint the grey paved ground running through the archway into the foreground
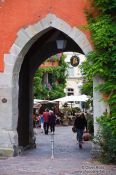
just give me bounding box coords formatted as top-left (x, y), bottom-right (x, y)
top-left (0, 126), bottom-right (116, 175)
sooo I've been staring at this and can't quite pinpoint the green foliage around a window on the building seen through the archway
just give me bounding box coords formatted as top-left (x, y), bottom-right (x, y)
top-left (34, 55), bottom-right (67, 100)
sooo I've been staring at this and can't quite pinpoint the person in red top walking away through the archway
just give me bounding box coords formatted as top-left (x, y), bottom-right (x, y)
top-left (43, 109), bottom-right (49, 134)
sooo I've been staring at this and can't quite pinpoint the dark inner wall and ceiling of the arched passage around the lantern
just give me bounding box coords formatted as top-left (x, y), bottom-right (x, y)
top-left (17, 28), bottom-right (83, 147)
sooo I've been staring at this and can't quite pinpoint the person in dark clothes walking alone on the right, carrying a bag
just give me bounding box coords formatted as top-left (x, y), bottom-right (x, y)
top-left (74, 113), bottom-right (87, 149)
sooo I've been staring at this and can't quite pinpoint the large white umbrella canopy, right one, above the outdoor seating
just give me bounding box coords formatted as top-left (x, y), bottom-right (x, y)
top-left (53, 94), bottom-right (89, 102)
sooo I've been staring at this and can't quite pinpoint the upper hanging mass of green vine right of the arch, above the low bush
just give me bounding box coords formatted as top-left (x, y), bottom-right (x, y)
top-left (81, 0), bottom-right (116, 113)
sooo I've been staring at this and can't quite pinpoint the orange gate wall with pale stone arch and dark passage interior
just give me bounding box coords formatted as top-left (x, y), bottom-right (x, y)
top-left (0, 0), bottom-right (108, 156)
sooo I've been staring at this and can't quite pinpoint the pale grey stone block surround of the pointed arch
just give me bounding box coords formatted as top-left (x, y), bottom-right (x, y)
top-left (0, 14), bottom-right (109, 156)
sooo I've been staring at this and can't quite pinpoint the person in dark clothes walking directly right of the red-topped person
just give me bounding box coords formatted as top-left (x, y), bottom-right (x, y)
top-left (49, 110), bottom-right (56, 134)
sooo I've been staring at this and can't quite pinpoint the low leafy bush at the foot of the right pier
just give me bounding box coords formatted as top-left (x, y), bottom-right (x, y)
top-left (97, 114), bottom-right (116, 163)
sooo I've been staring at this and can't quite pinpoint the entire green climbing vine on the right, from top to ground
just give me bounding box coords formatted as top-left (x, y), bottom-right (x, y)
top-left (81, 0), bottom-right (116, 162)
